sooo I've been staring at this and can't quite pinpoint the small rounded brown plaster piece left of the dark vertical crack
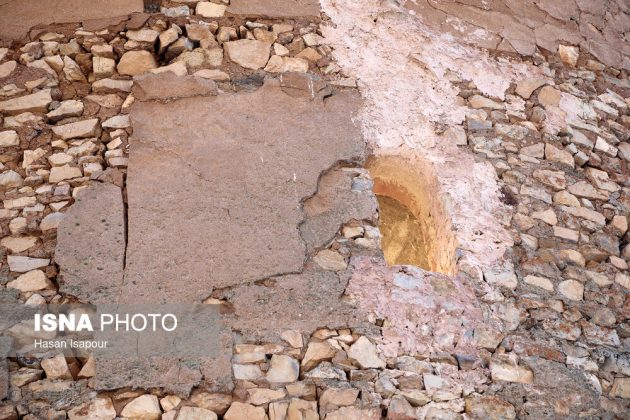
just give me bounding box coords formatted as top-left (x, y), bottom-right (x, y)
top-left (55, 182), bottom-right (125, 304)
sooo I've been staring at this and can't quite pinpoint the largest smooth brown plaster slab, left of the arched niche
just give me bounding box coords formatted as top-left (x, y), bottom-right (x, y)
top-left (121, 77), bottom-right (365, 303)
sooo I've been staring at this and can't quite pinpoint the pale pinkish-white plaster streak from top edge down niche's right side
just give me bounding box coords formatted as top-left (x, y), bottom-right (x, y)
top-left (321, 0), bottom-right (524, 267)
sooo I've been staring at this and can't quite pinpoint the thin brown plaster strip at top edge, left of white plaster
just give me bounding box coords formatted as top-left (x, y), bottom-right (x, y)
top-left (227, 0), bottom-right (320, 18)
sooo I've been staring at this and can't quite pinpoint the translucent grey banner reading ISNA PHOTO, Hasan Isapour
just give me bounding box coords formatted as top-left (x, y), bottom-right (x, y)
top-left (0, 304), bottom-right (226, 359)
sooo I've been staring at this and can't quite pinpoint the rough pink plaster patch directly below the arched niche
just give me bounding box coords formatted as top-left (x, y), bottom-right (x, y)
top-left (346, 257), bottom-right (483, 357)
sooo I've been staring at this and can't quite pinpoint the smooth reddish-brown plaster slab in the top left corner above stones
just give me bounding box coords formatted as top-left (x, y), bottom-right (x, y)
top-left (0, 0), bottom-right (144, 40)
